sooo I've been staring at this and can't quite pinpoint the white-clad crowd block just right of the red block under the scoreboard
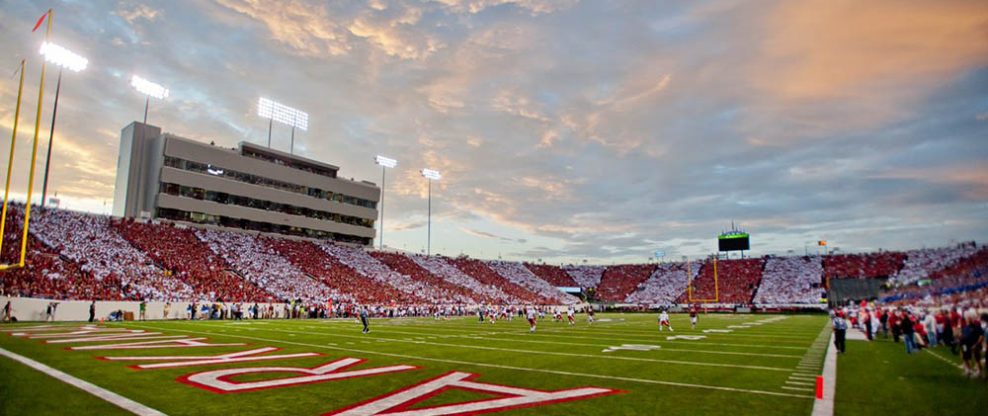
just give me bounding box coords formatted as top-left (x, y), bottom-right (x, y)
top-left (754, 256), bottom-right (825, 305)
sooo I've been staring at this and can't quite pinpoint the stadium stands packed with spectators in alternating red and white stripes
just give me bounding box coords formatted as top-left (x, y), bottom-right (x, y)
top-left (0, 205), bottom-right (988, 305)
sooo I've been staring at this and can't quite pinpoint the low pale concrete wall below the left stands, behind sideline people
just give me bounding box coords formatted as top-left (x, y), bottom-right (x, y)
top-left (0, 296), bottom-right (284, 322)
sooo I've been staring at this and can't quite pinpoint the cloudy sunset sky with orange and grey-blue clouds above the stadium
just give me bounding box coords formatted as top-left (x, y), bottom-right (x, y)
top-left (0, 0), bottom-right (988, 263)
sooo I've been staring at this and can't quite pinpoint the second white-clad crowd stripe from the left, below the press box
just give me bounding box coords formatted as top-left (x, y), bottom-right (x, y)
top-left (196, 229), bottom-right (343, 304)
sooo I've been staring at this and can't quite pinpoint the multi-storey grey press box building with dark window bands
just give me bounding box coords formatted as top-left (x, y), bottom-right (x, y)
top-left (113, 122), bottom-right (381, 246)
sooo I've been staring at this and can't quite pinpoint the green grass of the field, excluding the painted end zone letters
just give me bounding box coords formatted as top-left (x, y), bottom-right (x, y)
top-left (0, 314), bottom-right (988, 416)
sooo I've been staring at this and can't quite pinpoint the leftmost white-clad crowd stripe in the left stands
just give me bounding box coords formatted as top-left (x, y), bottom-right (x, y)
top-left (31, 209), bottom-right (193, 300)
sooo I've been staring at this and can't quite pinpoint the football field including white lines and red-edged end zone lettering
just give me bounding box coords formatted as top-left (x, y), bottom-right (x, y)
top-left (0, 314), bottom-right (977, 416)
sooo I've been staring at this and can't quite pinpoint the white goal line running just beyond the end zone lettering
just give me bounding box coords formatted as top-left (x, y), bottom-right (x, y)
top-left (117, 324), bottom-right (812, 399)
